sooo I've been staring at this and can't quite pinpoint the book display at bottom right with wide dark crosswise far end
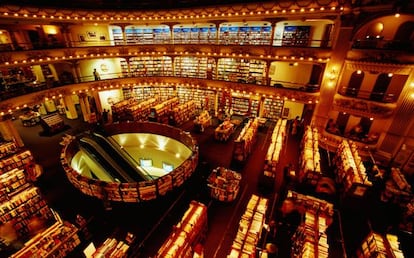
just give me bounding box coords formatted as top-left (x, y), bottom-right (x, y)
top-left (286, 191), bottom-right (334, 258)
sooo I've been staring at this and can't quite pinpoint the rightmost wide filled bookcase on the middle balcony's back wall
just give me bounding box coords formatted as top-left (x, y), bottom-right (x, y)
top-left (217, 57), bottom-right (266, 84)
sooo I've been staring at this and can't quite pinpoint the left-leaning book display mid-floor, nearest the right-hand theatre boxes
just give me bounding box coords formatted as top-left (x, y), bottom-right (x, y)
top-left (334, 140), bottom-right (372, 197)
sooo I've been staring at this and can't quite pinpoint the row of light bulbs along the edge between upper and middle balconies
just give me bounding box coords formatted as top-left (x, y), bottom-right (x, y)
top-left (4, 52), bottom-right (330, 66)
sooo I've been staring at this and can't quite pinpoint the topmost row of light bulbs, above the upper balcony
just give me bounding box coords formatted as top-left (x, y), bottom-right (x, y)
top-left (3, 6), bottom-right (344, 22)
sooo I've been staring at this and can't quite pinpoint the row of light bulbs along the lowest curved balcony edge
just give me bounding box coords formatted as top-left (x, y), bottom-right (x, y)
top-left (0, 82), bottom-right (319, 116)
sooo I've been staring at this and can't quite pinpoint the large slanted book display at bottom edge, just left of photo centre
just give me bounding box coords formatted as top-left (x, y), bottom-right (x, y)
top-left (155, 200), bottom-right (207, 258)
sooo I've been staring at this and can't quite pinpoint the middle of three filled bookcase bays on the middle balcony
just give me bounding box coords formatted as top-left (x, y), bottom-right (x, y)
top-left (174, 56), bottom-right (216, 80)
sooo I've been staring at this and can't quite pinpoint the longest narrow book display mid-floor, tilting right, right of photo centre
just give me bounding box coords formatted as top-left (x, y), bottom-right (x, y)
top-left (264, 119), bottom-right (287, 177)
